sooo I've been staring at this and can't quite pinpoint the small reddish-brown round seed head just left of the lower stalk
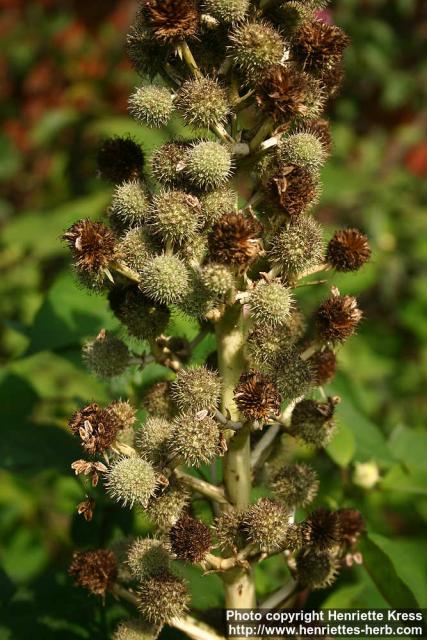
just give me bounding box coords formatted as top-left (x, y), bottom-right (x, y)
top-left (169, 515), bottom-right (212, 563)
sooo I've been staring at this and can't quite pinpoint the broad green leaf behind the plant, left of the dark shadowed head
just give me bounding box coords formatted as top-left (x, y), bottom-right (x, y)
top-left (25, 274), bottom-right (117, 356)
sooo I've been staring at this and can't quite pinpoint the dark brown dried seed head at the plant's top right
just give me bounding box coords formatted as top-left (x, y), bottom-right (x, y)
top-left (292, 20), bottom-right (350, 74)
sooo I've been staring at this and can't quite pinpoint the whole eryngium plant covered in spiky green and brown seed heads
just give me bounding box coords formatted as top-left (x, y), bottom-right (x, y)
top-left (64, 0), bottom-right (371, 640)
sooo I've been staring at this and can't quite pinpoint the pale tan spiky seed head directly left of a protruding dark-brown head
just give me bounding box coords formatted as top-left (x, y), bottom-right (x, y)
top-left (267, 216), bottom-right (324, 275)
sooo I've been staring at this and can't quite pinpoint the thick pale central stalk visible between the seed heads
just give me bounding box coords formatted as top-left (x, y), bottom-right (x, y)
top-left (216, 304), bottom-right (256, 609)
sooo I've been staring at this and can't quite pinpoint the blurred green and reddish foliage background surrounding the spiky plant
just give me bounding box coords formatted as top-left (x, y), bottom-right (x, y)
top-left (0, 0), bottom-right (427, 640)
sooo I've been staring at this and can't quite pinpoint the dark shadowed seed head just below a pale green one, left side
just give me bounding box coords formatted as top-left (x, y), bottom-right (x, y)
top-left (108, 285), bottom-right (170, 340)
